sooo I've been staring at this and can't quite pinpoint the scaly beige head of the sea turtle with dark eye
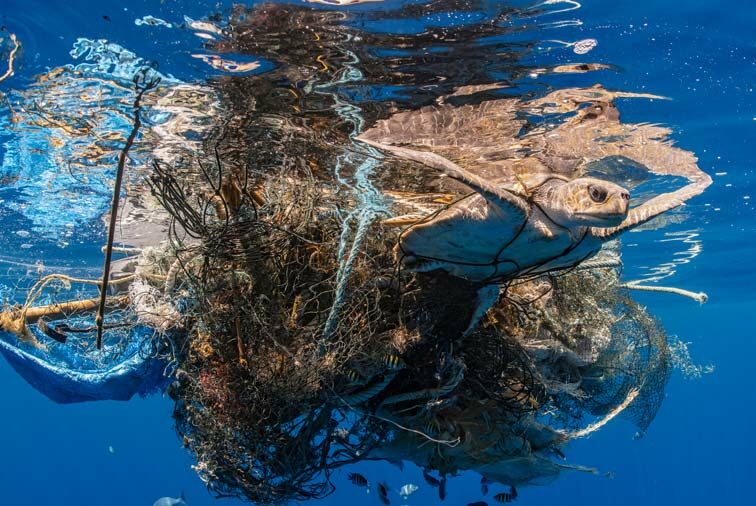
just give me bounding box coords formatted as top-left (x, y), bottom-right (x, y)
top-left (548, 177), bottom-right (630, 227)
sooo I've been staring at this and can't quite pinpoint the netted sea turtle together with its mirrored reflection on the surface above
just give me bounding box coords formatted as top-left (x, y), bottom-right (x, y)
top-left (357, 87), bottom-right (711, 330)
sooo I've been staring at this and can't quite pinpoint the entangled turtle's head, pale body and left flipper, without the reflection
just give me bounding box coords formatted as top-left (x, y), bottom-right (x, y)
top-left (364, 153), bottom-right (636, 282)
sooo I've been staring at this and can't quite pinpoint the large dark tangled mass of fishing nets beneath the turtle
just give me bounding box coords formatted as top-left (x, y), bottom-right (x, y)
top-left (145, 139), bottom-right (670, 503)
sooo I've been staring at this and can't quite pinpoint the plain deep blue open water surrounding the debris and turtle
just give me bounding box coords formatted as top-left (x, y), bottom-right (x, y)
top-left (0, 0), bottom-right (756, 506)
